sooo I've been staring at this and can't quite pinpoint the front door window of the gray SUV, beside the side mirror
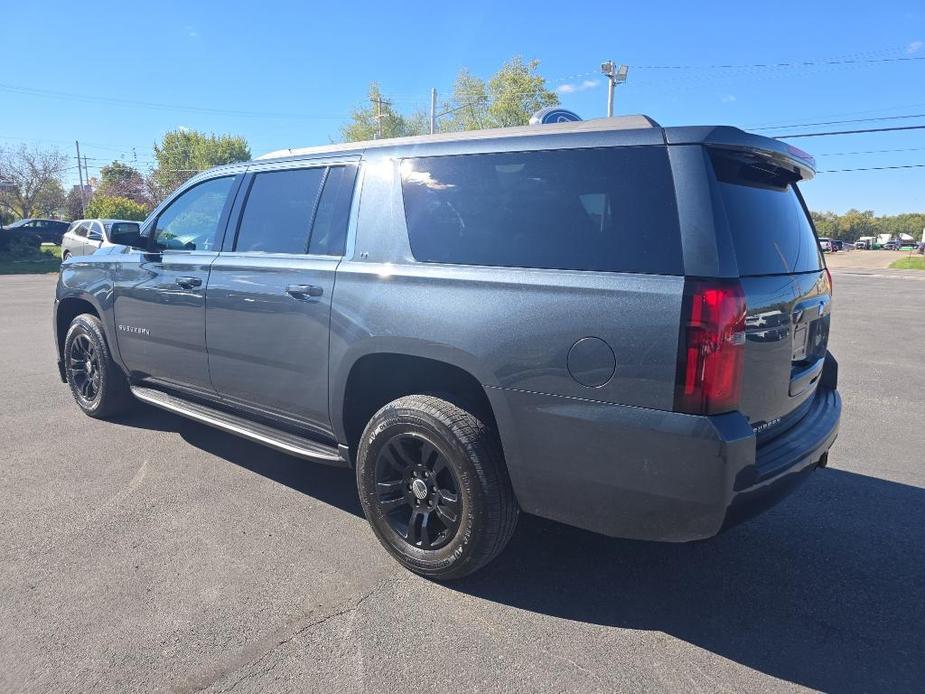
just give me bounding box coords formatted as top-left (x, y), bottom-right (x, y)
top-left (154, 176), bottom-right (234, 251)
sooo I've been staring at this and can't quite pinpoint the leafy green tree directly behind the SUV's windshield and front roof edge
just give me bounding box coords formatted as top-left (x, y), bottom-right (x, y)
top-left (148, 128), bottom-right (251, 203)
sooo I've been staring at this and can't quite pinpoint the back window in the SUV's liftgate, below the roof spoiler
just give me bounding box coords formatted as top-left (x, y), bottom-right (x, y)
top-left (710, 150), bottom-right (822, 276)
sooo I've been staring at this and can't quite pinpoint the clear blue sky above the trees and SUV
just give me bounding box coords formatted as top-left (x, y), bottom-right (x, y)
top-left (0, 0), bottom-right (925, 214)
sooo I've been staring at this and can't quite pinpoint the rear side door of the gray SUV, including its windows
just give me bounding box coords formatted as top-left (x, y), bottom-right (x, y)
top-left (206, 162), bottom-right (356, 433)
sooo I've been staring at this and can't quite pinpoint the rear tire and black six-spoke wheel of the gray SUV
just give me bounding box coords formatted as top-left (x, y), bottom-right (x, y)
top-left (356, 395), bottom-right (519, 580)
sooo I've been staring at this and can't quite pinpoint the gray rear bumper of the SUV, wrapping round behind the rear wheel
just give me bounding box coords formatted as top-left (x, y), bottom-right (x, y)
top-left (489, 386), bottom-right (841, 542)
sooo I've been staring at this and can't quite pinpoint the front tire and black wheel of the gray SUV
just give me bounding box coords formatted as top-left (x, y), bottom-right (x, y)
top-left (64, 313), bottom-right (134, 419)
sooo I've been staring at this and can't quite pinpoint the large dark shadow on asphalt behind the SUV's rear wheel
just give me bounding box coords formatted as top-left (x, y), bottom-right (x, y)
top-left (452, 469), bottom-right (925, 692)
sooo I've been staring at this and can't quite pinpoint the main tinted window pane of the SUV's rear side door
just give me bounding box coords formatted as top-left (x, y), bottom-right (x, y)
top-left (235, 167), bottom-right (324, 253)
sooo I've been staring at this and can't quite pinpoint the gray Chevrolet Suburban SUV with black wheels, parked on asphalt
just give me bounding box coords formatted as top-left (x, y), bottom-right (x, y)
top-left (54, 116), bottom-right (841, 579)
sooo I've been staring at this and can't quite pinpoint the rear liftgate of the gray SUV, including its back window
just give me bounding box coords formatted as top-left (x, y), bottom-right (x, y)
top-left (710, 149), bottom-right (832, 439)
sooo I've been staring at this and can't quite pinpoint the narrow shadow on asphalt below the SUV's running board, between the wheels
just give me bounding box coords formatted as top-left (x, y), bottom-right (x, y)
top-left (113, 406), bottom-right (365, 518)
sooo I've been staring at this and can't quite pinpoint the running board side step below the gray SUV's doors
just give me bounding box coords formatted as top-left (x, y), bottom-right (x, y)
top-left (131, 386), bottom-right (350, 467)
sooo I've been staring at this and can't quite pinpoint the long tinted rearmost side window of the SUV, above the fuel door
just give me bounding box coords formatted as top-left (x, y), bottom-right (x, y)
top-left (401, 147), bottom-right (682, 275)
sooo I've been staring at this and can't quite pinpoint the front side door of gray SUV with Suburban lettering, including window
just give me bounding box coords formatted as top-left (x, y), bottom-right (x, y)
top-left (114, 176), bottom-right (239, 392)
